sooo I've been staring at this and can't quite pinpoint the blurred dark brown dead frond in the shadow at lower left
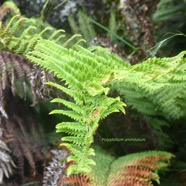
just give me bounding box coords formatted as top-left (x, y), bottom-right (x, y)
top-left (2, 93), bottom-right (46, 180)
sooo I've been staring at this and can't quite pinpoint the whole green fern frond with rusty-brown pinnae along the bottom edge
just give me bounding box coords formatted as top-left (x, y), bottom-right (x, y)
top-left (54, 147), bottom-right (174, 186)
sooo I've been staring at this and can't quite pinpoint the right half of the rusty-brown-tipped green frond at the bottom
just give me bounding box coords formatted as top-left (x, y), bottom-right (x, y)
top-left (108, 151), bottom-right (173, 186)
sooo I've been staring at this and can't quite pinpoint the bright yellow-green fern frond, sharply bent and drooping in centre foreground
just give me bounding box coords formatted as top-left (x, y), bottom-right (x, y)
top-left (0, 16), bottom-right (176, 182)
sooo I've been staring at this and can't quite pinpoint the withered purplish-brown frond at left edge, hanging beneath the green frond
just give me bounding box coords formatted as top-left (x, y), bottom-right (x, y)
top-left (0, 51), bottom-right (53, 117)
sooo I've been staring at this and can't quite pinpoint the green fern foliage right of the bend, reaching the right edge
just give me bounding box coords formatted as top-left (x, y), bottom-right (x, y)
top-left (110, 51), bottom-right (186, 119)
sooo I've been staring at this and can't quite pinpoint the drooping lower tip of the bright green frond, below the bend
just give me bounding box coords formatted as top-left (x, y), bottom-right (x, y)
top-left (47, 87), bottom-right (124, 174)
